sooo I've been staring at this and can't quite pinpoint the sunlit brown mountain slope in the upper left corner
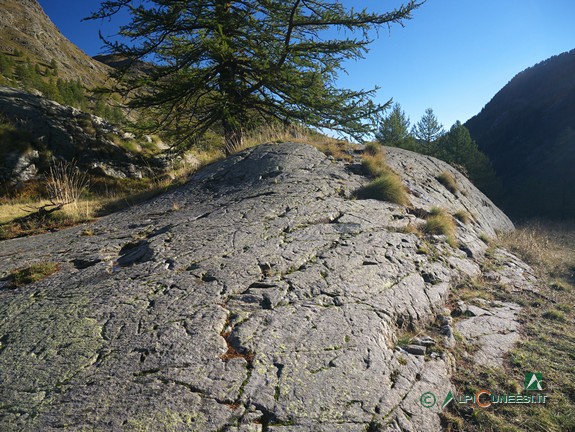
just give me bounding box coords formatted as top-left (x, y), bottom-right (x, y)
top-left (0, 0), bottom-right (110, 88)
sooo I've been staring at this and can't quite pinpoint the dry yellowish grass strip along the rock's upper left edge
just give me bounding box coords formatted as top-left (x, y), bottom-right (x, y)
top-left (0, 143), bottom-right (214, 240)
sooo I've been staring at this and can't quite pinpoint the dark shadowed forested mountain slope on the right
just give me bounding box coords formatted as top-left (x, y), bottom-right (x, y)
top-left (465, 50), bottom-right (575, 219)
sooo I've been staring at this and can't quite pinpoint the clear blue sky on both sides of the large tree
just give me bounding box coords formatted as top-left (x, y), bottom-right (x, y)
top-left (39, 0), bottom-right (575, 128)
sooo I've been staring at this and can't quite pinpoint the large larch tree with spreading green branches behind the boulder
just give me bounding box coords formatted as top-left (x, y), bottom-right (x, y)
top-left (90, 0), bottom-right (425, 154)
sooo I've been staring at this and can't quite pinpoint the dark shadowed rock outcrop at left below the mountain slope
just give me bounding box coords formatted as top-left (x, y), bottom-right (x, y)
top-left (0, 87), bottom-right (166, 183)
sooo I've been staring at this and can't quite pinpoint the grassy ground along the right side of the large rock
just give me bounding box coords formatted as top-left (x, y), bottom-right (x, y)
top-left (442, 223), bottom-right (575, 432)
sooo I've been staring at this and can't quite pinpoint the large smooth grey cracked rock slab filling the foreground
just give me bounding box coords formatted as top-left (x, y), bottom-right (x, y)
top-left (0, 143), bottom-right (536, 432)
